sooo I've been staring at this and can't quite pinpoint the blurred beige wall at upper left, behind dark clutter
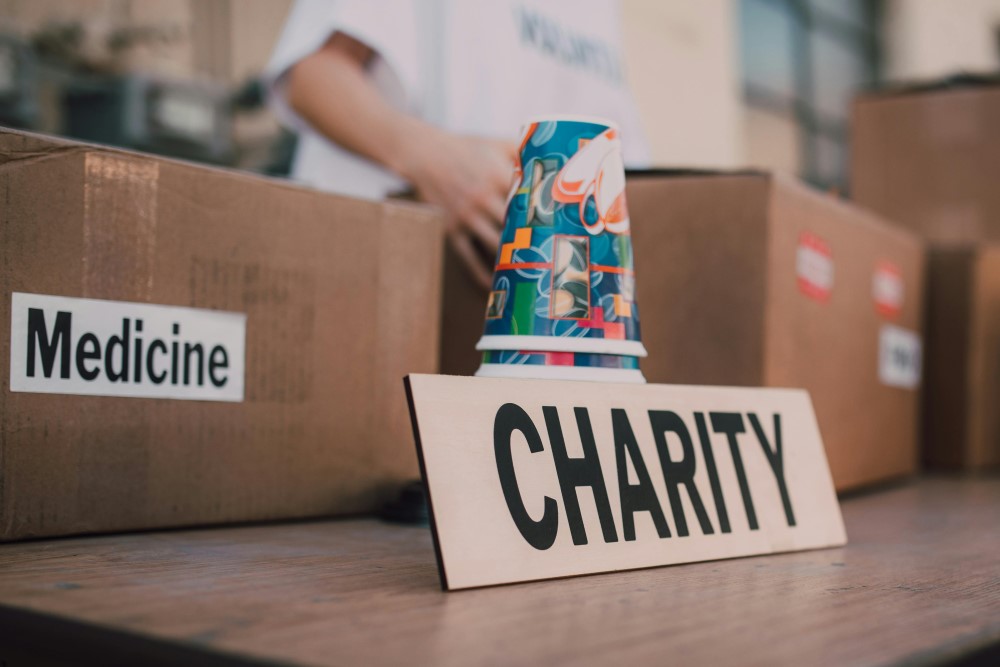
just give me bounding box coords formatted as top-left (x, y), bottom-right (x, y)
top-left (0, 0), bottom-right (292, 162)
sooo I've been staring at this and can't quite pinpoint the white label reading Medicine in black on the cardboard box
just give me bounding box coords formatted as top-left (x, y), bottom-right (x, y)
top-left (10, 292), bottom-right (246, 402)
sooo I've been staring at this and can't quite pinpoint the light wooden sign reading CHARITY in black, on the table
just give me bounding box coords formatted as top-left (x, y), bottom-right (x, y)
top-left (406, 375), bottom-right (847, 590)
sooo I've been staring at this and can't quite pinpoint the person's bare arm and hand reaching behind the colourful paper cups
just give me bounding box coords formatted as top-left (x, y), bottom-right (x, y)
top-left (286, 33), bottom-right (517, 289)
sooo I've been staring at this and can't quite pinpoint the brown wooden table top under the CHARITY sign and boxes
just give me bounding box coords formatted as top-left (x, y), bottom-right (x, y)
top-left (0, 478), bottom-right (1000, 667)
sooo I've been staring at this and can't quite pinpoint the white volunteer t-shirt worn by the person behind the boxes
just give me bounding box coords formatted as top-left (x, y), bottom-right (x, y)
top-left (265, 0), bottom-right (649, 198)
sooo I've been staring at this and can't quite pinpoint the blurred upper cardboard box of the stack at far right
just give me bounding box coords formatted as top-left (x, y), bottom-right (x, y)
top-left (851, 79), bottom-right (1000, 243)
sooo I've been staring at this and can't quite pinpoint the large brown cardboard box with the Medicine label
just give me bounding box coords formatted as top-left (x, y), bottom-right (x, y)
top-left (0, 126), bottom-right (442, 540)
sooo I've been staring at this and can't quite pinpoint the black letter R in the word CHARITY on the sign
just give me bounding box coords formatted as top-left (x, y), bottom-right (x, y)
top-left (649, 410), bottom-right (714, 537)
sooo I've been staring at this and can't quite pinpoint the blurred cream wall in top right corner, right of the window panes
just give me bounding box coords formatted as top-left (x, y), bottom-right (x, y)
top-left (883, 0), bottom-right (1000, 80)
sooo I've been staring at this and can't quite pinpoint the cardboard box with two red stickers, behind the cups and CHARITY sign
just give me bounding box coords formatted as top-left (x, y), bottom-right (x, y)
top-left (441, 173), bottom-right (924, 490)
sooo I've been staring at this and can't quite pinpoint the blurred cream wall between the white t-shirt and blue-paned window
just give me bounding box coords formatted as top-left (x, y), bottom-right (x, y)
top-left (622, 0), bottom-right (744, 167)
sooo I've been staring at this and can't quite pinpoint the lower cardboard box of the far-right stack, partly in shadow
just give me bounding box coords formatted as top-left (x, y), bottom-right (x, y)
top-left (923, 245), bottom-right (1000, 469)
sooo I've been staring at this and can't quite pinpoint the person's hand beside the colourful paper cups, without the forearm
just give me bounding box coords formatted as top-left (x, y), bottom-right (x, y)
top-left (396, 126), bottom-right (517, 289)
